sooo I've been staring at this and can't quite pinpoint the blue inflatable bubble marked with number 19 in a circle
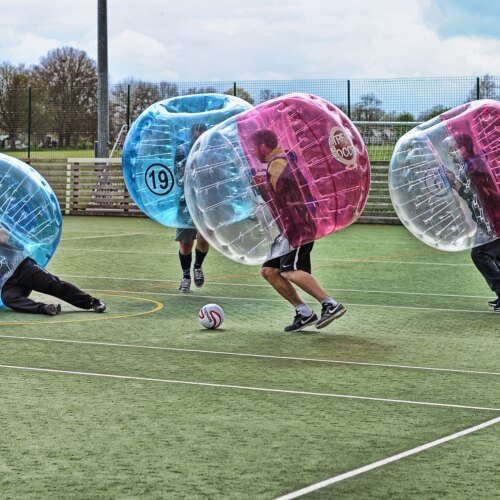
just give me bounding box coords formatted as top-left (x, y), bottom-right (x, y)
top-left (122, 94), bottom-right (252, 228)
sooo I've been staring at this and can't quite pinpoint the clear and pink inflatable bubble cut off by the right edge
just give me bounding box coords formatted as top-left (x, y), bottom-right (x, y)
top-left (389, 99), bottom-right (500, 251)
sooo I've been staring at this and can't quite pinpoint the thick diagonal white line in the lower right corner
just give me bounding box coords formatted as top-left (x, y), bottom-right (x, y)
top-left (276, 417), bottom-right (500, 500)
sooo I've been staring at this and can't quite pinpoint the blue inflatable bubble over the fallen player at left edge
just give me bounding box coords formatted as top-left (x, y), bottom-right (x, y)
top-left (0, 154), bottom-right (62, 305)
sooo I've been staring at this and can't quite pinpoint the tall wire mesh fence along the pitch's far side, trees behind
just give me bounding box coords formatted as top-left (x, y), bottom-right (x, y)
top-left (0, 75), bottom-right (500, 220)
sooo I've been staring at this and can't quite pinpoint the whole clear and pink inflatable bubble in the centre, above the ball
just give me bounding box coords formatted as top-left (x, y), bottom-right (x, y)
top-left (185, 93), bottom-right (370, 264)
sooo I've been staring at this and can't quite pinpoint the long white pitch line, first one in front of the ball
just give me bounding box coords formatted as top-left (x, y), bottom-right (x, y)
top-left (0, 335), bottom-right (500, 376)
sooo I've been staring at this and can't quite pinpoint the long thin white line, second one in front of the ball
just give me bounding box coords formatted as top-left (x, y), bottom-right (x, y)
top-left (0, 365), bottom-right (500, 411)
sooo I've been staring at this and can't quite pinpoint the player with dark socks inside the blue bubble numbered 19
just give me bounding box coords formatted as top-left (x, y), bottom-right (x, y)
top-left (175, 123), bottom-right (210, 293)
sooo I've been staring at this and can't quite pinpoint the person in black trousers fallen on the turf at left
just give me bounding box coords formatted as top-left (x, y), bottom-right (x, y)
top-left (0, 228), bottom-right (106, 316)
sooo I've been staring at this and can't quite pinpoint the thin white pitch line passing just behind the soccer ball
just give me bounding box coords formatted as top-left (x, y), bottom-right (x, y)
top-left (84, 288), bottom-right (499, 316)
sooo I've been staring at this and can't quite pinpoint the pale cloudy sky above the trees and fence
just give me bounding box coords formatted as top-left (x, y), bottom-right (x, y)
top-left (0, 0), bottom-right (500, 83)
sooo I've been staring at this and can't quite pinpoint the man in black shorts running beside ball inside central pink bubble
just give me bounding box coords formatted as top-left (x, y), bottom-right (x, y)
top-left (252, 130), bottom-right (346, 332)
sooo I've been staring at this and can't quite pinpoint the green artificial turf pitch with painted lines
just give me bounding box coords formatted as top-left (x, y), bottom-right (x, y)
top-left (0, 217), bottom-right (500, 499)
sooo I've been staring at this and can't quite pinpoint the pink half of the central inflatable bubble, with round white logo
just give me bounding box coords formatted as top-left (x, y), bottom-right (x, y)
top-left (237, 94), bottom-right (370, 247)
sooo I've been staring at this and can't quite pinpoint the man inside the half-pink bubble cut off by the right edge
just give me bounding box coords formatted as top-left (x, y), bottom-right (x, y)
top-left (446, 134), bottom-right (500, 312)
